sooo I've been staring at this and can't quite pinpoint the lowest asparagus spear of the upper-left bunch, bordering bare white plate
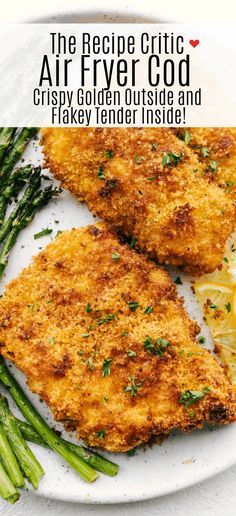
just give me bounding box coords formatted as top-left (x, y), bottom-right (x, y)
top-left (0, 181), bottom-right (61, 279)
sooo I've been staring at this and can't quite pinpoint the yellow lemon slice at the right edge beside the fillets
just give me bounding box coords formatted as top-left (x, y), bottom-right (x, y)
top-left (194, 278), bottom-right (236, 383)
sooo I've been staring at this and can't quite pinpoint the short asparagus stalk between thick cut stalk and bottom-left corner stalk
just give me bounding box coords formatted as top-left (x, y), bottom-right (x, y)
top-left (0, 424), bottom-right (25, 487)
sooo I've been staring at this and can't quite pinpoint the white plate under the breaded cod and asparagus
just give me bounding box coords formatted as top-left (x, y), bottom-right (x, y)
top-left (0, 133), bottom-right (236, 503)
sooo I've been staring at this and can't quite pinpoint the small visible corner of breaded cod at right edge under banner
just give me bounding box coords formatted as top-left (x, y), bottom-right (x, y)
top-left (173, 127), bottom-right (236, 192)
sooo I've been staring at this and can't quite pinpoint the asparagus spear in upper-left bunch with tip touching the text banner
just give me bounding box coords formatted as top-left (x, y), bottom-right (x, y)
top-left (0, 127), bottom-right (38, 185)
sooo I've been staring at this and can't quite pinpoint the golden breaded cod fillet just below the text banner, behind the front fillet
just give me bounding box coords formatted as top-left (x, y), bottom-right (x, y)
top-left (42, 128), bottom-right (235, 274)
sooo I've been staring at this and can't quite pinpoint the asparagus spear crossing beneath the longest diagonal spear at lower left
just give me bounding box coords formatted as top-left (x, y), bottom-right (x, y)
top-left (16, 418), bottom-right (119, 477)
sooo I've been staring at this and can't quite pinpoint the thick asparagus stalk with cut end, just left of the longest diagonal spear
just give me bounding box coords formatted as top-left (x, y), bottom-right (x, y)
top-left (0, 396), bottom-right (44, 489)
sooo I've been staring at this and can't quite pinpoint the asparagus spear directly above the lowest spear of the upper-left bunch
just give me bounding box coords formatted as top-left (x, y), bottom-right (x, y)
top-left (0, 167), bottom-right (41, 243)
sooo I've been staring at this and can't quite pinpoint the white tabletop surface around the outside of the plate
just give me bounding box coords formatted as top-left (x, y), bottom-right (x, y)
top-left (0, 0), bottom-right (236, 516)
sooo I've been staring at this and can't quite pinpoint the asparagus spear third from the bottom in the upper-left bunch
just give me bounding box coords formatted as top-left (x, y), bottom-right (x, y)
top-left (0, 165), bottom-right (33, 227)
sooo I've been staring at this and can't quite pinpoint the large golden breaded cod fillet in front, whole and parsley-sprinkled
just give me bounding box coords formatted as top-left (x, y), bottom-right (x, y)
top-left (0, 223), bottom-right (235, 451)
